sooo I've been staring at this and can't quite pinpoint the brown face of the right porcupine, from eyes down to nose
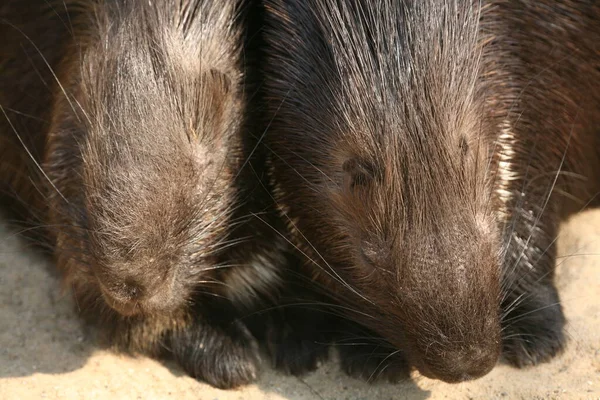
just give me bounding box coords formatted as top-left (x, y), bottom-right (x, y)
top-left (331, 132), bottom-right (501, 382)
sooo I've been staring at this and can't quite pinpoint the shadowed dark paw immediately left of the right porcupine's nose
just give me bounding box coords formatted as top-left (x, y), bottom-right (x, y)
top-left (338, 342), bottom-right (410, 383)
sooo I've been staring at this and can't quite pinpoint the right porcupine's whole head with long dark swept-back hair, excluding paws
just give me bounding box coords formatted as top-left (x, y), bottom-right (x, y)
top-left (265, 0), bottom-right (502, 382)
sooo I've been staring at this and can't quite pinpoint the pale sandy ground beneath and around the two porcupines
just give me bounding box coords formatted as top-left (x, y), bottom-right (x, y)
top-left (0, 211), bottom-right (600, 400)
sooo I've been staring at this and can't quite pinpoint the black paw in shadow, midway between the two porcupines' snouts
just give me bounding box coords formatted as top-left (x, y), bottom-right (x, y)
top-left (267, 316), bottom-right (329, 376)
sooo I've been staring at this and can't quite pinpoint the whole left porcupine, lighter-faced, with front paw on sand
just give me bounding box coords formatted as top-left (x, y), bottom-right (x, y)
top-left (0, 0), bottom-right (283, 388)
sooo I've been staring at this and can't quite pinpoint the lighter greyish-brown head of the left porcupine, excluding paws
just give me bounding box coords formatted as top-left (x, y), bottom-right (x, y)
top-left (45, 6), bottom-right (240, 316)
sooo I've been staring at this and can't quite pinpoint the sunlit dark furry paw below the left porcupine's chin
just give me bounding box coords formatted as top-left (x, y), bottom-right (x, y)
top-left (171, 322), bottom-right (260, 389)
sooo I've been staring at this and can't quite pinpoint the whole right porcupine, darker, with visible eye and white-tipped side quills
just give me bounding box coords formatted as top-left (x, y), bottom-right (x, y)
top-left (263, 0), bottom-right (600, 382)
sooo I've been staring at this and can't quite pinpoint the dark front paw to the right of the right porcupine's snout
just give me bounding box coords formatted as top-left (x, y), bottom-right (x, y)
top-left (503, 286), bottom-right (566, 368)
